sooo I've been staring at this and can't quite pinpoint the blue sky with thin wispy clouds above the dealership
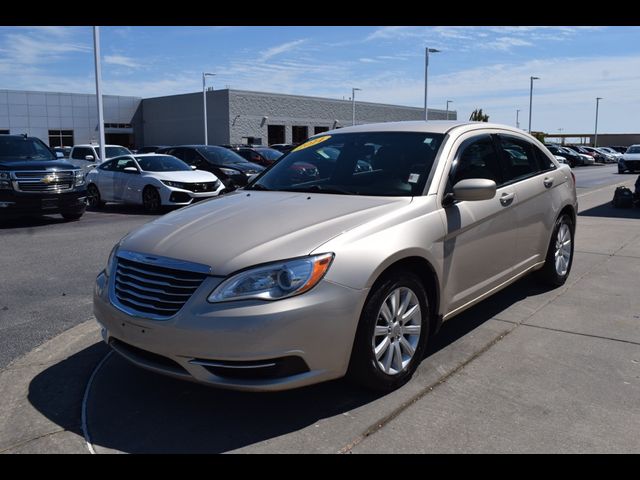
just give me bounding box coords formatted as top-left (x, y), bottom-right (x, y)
top-left (0, 26), bottom-right (640, 133)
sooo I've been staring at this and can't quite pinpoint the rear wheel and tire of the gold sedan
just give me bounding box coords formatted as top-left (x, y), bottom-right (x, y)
top-left (538, 213), bottom-right (575, 287)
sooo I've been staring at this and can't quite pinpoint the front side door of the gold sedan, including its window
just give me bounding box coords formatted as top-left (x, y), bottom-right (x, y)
top-left (440, 132), bottom-right (518, 314)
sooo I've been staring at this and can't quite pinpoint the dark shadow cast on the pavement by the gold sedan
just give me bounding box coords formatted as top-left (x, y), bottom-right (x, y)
top-left (29, 278), bottom-right (545, 453)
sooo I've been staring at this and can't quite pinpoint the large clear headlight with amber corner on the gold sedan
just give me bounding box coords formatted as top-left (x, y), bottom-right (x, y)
top-left (207, 253), bottom-right (333, 303)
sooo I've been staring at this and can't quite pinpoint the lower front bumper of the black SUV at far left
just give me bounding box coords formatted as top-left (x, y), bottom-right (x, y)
top-left (0, 188), bottom-right (87, 217)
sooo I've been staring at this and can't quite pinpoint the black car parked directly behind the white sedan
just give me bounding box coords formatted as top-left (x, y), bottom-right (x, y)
top-left (156, 145), bottom-right (264, 191)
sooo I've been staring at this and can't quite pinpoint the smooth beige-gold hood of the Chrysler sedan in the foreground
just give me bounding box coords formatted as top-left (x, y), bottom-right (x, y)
top-left (121, 190), bottom-right (411, 275)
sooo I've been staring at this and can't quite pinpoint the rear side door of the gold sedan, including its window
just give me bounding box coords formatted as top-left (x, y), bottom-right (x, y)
top-left (497, 134), bottom-right (565, 271)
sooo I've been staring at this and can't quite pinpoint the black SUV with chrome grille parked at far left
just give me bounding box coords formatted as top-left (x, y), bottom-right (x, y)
top-left (0, 135), bottom-right (87, 220)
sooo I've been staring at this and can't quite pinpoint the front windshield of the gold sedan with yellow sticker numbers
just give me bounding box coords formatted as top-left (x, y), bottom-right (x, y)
top-left (247, 132), bottom-right (444, 196)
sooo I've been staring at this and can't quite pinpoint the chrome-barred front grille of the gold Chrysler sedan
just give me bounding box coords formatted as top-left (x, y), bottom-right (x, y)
top-left (113, 252), bottom-right (206, 319)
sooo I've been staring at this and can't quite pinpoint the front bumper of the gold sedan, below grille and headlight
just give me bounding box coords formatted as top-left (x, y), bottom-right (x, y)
top-left (93, 272), bottom-right (368, 391)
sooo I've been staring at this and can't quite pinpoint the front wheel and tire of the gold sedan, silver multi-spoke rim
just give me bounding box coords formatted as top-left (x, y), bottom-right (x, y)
top-left (347, 270), bottom-right (431, 392)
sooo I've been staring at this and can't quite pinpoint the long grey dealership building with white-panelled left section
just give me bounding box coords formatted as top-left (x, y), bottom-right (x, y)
top-left (0, 89), bottom-right (457, 148)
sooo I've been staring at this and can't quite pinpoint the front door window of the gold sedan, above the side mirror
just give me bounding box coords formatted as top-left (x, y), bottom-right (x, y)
top-left (449, 135), bottom-right (502, 186)
